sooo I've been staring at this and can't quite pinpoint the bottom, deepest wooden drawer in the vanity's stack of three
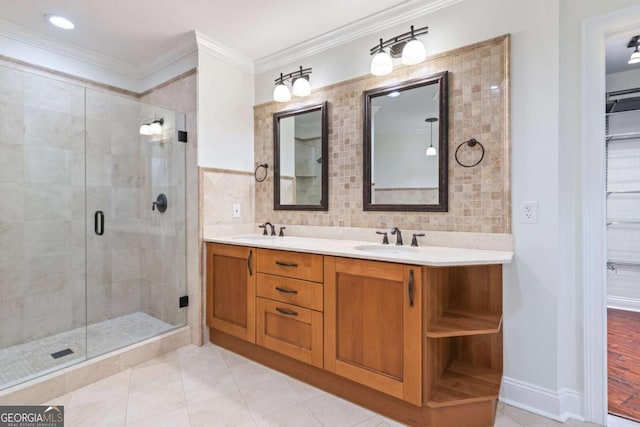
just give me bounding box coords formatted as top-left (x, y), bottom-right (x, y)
top-left (256, 298), bottom-right (323, 368)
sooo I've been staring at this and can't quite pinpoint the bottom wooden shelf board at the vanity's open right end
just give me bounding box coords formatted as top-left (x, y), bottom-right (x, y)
top-left (427, 360), bottom-right (502, 408)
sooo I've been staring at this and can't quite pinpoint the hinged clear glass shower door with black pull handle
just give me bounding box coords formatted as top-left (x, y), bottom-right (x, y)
top-left (86, 89), bottom-right (186, 357)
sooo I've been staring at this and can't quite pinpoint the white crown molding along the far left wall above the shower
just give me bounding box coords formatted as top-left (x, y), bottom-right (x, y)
top-left (0, 19), bottom-right (142, 78)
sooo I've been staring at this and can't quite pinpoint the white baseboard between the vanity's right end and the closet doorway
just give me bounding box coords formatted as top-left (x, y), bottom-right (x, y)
top-left (500, 377), bottom-right (584, 422)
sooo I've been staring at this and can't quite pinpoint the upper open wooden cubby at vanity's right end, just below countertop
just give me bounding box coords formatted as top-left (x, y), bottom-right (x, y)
top-left (425, 265), bottom-right (502, 338)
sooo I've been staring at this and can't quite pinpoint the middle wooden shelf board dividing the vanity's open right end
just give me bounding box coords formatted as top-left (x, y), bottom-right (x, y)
top-left (427, 307), bottom-right (502, 338)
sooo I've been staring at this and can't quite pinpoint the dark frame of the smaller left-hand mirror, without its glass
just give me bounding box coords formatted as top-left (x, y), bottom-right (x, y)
top-left (273, 101), bottom-right (329, 211)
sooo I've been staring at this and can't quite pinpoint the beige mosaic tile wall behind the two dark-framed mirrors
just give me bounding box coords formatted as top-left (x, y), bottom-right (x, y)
top-left (254, 36), bottom-right (511, 233)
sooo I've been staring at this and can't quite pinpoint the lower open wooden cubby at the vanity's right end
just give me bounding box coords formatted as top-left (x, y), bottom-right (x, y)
top-left (425, 333), bottom-right (502, 408)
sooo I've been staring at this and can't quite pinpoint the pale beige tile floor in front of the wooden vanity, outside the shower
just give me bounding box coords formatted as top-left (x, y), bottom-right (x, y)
top-left (41, 343), bottom-right (604, 427)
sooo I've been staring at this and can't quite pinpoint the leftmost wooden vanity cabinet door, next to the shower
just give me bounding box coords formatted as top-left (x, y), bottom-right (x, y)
top-left (207, 243), bottom-right (256, 343)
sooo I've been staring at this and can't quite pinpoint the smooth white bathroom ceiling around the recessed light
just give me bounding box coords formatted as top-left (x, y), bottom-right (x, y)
top-left (0, 0), bottom-right (416, 66)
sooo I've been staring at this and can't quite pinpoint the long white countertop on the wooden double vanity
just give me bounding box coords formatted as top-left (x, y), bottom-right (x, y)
top-left (205, 234), bottom-right (513, 267)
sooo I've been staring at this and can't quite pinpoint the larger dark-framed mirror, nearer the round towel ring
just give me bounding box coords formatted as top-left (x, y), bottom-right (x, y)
top-left (363, 71), bottom-right (449, 212)
